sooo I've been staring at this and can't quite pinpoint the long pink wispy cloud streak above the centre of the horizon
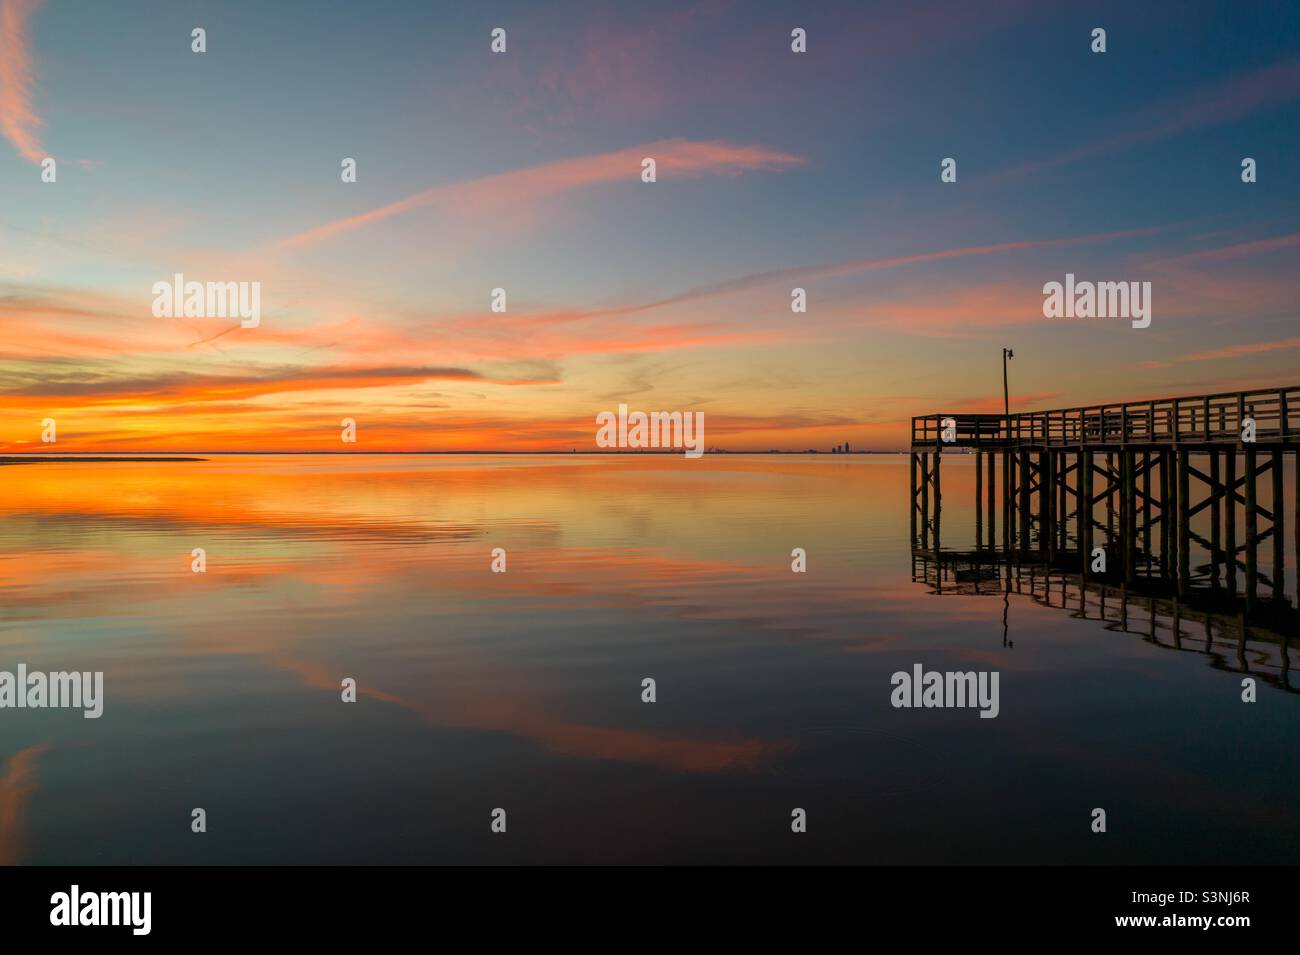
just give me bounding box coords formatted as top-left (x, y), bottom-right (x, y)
top-left (276, 139), bottom-right (803, 251)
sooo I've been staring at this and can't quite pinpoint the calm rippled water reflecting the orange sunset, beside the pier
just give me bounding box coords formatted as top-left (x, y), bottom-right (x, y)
top-left (0, 456), bottom-right (1300, 864)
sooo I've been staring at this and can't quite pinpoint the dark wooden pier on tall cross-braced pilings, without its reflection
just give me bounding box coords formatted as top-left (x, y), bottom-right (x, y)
top-left (911, 386), bottom-right (1300, 616)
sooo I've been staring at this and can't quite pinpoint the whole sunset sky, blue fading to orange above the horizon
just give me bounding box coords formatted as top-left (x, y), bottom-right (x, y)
top-left (0, 0), bottom-right (1300, 452)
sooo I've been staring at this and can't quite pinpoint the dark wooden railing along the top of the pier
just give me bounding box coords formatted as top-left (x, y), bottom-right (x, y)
top-left (911, 386), bottom-right (1300, 448)
